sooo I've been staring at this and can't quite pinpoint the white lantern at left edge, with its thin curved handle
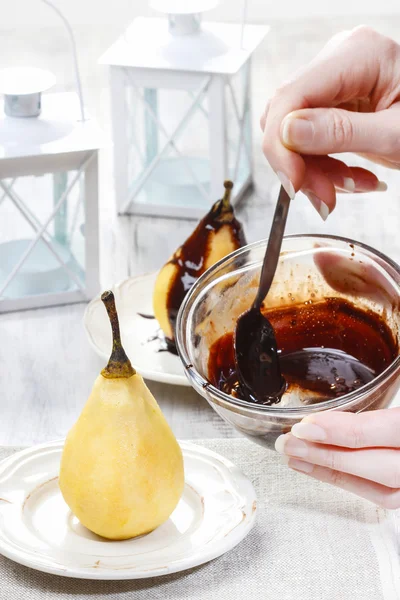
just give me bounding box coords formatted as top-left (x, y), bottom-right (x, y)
top-left (0, 0), bottom-right (103, 313)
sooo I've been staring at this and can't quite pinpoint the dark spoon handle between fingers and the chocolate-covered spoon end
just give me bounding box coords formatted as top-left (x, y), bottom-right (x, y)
top-left (253, 186), bottom-right (290, 310)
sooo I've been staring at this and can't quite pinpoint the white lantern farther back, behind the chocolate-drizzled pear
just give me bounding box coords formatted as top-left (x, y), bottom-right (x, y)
top-left (100, 0), bottom-right (268, 218)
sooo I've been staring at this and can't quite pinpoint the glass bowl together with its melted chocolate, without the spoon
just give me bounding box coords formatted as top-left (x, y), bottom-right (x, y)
top-left (176, 235), bottom-right (400, 448)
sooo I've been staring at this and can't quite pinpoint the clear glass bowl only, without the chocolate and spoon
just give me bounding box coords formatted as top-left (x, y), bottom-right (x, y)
top-left (176, 235), bottom-right (400, 449)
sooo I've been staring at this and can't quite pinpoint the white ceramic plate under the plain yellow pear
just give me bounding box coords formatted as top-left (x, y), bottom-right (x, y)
top-left (0, 441), bottom-right (256, 579)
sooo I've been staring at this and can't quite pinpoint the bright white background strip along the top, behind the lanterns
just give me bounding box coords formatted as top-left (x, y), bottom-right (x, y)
top-left (0, 0), bottom-right (400, 27)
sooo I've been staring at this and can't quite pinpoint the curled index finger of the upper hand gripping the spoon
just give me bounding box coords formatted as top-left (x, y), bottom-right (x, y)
top-left (263, 27), bottom-right (383, 191)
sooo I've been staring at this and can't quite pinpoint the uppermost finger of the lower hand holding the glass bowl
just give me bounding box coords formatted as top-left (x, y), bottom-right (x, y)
top-left (291, 408), bottom-right (400, 448)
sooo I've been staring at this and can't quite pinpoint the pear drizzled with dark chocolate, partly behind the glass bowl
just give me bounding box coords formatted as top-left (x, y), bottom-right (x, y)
top-left (153, 181), bottom-right (246, 349)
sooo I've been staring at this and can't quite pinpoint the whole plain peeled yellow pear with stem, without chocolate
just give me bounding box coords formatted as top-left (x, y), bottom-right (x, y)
top-left (59, 292), bottom-right (184, 540)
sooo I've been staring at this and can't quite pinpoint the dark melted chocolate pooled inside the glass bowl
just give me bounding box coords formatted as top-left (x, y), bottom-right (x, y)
top-left (208, 298), bottom-right (398, 406)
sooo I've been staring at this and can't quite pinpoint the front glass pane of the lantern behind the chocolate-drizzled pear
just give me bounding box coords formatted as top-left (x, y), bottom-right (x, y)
top-left (126, 86), bottom-right (210, 215)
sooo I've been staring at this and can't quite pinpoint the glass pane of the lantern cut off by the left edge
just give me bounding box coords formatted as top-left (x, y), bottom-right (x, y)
top-left (0, 171), bottom-right (85, 298)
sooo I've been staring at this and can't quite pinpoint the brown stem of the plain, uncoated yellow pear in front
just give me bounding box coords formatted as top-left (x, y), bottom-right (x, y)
top-left (101, 291), bottom-right (136, 379)
